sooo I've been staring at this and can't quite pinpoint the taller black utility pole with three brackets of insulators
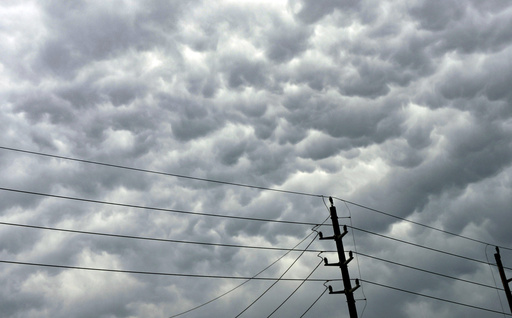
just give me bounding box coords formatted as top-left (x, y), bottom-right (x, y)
top-left (318, 197), bottom-right (359, 318)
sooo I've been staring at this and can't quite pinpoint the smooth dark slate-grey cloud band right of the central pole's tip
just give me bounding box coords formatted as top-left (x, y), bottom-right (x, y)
top-left (352, 113), bottom-right (512, 232)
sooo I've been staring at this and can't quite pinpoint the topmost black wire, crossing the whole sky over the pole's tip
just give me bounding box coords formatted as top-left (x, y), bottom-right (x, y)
top-left (0, 146), bottom-right (512, 251)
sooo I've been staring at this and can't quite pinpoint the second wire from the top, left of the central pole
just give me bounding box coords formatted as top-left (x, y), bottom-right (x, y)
top-left (0, 187), bottom-right (324, 226)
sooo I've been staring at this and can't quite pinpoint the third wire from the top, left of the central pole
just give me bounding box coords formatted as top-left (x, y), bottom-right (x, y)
top-left (0, 222), bottom-right (335, 253)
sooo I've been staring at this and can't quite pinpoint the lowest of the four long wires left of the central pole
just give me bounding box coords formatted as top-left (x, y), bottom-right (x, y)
top-left (0, 260), bottom-right (338, 282)
